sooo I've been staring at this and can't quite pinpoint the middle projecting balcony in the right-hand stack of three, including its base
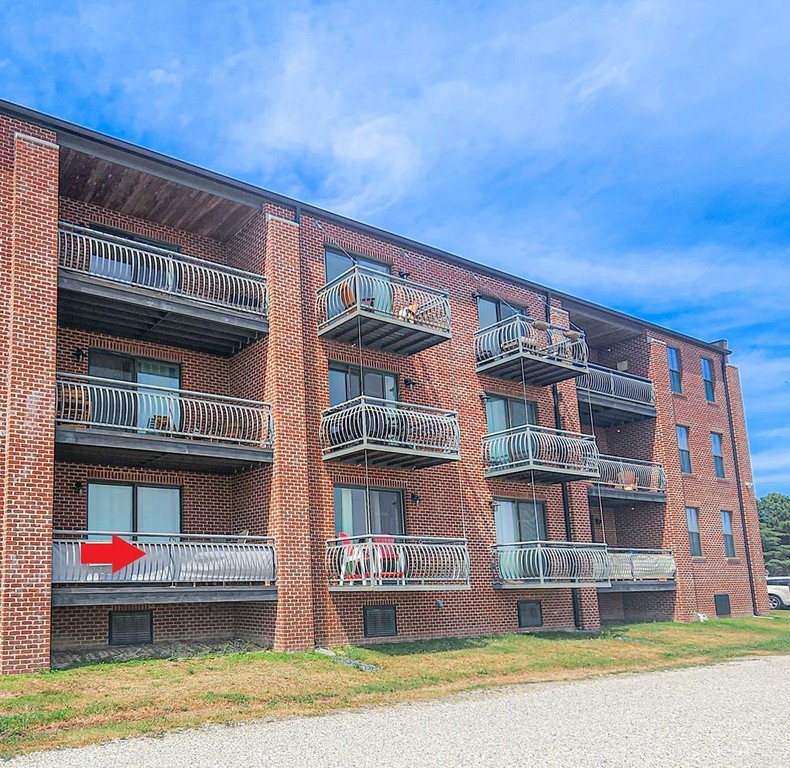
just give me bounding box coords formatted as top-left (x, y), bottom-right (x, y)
top-left (483, 424), bottom-right (598, 483)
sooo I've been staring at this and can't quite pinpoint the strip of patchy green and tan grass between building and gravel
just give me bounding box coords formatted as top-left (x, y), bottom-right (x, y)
top-left (0, 611), bottom-right (790, 758)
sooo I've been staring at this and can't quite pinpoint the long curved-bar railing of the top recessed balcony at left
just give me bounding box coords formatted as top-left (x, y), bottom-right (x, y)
top-left (58, 223), bottom-right (267, 316)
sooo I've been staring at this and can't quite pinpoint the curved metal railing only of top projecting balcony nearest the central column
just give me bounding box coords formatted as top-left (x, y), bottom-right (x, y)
top-left (316, 264), bottom-right (450, 333)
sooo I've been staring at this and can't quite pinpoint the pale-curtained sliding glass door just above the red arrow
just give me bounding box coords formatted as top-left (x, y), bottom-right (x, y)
top-left (88, 482), bottom-right (181, 541)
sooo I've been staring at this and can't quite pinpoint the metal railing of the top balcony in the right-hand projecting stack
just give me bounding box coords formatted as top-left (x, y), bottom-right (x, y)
top-left (475, 315), bottom-right (588, 369)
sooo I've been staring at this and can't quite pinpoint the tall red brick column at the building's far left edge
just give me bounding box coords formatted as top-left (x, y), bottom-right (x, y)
top-left (0, 125), bottom-right (58, 674)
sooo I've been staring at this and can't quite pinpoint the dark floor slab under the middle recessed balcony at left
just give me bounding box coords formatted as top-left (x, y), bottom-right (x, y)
top-left (55, 426), bottom-right (272, 474)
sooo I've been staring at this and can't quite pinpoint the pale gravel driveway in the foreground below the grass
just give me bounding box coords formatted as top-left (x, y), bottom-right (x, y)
top-left (8, 657), bottom-right (790, 768)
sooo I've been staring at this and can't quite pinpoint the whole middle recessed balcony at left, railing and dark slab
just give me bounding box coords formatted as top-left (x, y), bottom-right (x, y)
top-left (55, 373), bottom-right (272, 474)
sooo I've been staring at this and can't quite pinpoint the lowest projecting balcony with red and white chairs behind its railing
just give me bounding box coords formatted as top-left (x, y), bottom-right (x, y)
top-left (326, 535), bottom-right (471, 592)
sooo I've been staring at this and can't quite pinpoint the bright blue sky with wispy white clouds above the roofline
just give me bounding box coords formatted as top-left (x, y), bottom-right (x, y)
top-left (0, 0), bottom-right (790, 495)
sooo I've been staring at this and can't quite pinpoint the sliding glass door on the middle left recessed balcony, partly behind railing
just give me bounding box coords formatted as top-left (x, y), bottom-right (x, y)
top-left (88, 349), bottom-right (181, 432)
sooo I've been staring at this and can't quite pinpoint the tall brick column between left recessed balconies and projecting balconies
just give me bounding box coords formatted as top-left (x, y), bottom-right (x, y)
top-left (265, 214), bottom-right (317, 651)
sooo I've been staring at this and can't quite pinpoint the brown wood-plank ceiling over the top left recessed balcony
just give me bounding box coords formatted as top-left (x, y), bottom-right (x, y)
top-left (60, 147), bottom-right (260, 242)
